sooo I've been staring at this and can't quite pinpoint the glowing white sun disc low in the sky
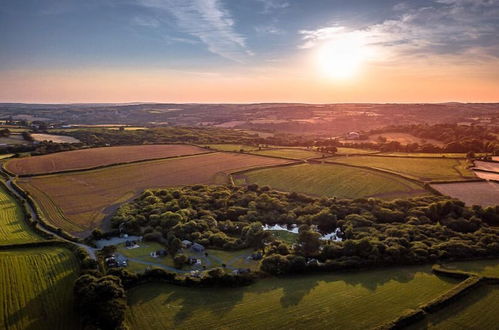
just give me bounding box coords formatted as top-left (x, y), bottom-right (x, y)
top-left (316, 36), bottom-right (369, 80)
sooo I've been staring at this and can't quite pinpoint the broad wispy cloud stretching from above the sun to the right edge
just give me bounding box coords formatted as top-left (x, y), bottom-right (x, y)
top-left (299, 0), bottom-right (499, 58)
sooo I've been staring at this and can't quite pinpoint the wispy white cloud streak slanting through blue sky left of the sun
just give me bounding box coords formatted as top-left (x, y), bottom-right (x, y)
top-left (137, 0), bottom-right (251, 62)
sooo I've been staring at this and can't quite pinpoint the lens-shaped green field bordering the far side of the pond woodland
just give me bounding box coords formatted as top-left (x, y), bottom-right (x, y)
top-left (238, 164), bottom-right (429, 198)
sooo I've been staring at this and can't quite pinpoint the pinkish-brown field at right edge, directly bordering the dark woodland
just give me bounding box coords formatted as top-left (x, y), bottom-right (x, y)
top-left (431, 181), bottom-right (499, 206)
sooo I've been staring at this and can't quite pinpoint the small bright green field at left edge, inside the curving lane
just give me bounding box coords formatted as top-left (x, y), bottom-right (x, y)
top-left (0, 187), bottom-right (41, 245)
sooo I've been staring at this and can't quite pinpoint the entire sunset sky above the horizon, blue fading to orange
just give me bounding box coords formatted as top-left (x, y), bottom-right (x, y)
top-left (0, 0), bottom-right (499, 103)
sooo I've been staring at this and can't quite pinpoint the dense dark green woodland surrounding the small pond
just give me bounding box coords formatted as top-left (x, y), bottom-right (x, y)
top-left (112, 185), bottom-right (499, 274)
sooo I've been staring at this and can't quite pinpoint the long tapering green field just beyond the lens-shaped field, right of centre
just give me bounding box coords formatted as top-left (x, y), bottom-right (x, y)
top-left (331, 156), bottom-right (476, 181)
